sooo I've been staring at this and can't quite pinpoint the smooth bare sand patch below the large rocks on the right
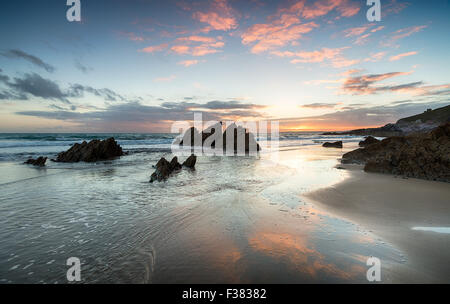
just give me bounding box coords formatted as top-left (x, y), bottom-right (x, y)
top-left (302, 165), bottom-right (450, 283)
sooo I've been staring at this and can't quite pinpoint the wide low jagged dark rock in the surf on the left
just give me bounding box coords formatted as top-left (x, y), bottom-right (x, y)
top-left (56, 137), bottom-right (124, 163)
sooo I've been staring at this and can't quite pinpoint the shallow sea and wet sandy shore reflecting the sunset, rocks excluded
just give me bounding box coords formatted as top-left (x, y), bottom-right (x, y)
top-left (0, 133), bottom-right (450, 284)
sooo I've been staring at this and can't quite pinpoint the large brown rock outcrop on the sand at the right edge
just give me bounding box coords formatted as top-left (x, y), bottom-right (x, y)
top-left (342, 123), bottom-right (450, 182)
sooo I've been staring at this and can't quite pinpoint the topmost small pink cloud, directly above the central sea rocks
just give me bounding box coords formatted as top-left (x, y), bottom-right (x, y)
top-left (192, 0), bottom-right (238, 32)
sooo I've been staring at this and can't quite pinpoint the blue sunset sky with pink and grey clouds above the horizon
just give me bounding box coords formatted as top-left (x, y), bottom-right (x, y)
top-left (0, 0), bottom-right (450, 132)
